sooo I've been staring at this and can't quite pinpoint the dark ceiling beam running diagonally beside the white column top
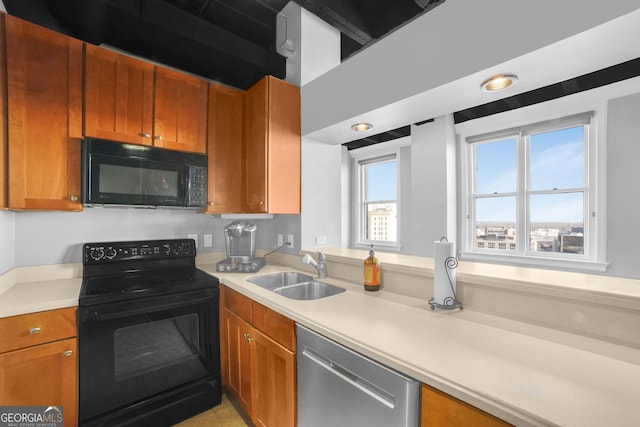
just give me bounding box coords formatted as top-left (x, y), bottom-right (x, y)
top-left (294, 0), bottom-right (373, 46)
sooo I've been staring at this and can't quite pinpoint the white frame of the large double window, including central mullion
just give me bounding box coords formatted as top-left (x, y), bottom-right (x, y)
top-left (456, 99), bottom-right (607, 272)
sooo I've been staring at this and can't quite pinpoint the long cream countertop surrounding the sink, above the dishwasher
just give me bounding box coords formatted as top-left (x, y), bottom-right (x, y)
top-left (200, 265), bottom-right (640, 427)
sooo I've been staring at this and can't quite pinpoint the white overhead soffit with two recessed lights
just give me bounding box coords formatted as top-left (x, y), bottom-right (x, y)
top-left (302, 0), bottom-right (640, 144)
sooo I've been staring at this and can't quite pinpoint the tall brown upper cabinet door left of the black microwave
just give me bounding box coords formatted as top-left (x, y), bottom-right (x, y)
top-left (5, 15), bottom-right (82, 210)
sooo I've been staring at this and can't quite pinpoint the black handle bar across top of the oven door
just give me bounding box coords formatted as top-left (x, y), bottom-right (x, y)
top-left (78, 294), bottom-right (214, 322)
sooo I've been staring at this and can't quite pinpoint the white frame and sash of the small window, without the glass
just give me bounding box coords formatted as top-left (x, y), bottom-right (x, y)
top-left (349, 138), bottom-right (409, 251)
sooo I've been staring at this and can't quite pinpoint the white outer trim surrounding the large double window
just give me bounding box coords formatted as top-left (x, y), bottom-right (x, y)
top-left (456, 84), bottom-right (612, 272)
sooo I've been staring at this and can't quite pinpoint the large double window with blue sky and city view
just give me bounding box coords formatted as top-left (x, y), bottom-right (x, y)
top-left (463, 112), bottom-right (601, 268)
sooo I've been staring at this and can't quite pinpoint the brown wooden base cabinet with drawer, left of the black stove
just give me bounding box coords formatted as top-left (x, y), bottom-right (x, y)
top-left (0, 308), bottom-right (78, 426)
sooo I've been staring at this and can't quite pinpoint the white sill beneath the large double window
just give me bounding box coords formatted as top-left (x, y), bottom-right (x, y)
top-left (460, 252), bottom-right (609, 273)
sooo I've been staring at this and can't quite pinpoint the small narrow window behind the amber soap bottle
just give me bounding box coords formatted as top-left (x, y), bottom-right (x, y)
top-left (350, 143), bottom-right (400, 250)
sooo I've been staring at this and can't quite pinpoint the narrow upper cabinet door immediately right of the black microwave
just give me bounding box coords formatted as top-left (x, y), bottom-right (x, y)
top-left (207, 83), bottom-right (244, 213)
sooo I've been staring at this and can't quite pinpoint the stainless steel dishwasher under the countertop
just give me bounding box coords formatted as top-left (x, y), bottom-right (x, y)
top-left (297, 325), bottom-right (420, 427)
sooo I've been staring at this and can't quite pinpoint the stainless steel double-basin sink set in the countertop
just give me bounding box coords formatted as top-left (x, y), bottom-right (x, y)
top-left (247, 272), bottom-right (344, 300)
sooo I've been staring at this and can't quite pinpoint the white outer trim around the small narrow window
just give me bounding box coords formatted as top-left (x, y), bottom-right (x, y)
top-left (349, 137), bottom-right (411, 252)
